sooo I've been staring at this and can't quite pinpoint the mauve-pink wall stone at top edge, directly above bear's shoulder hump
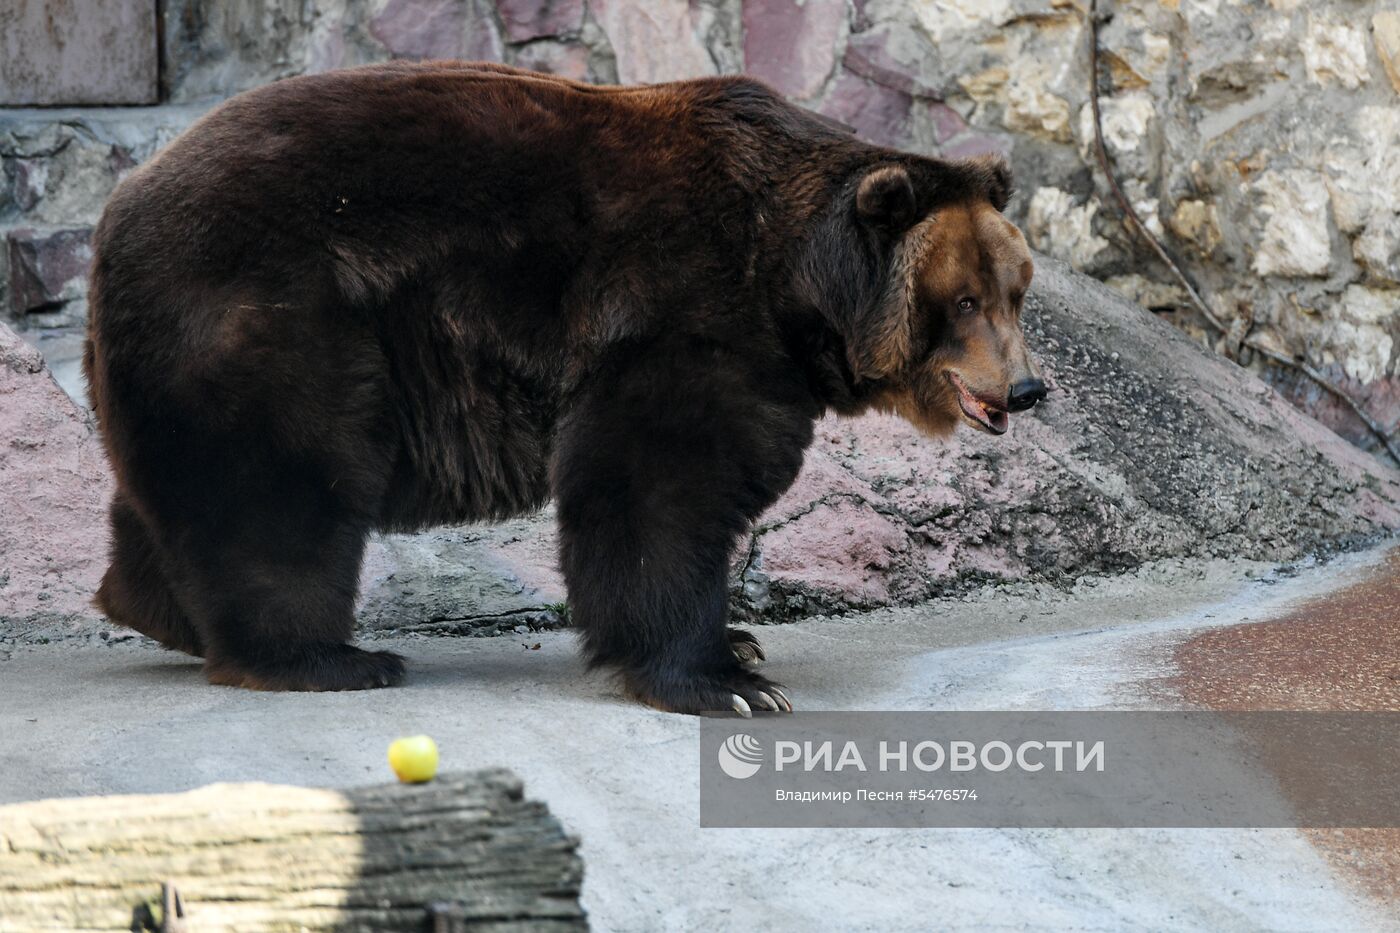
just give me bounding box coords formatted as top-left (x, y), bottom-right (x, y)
top-left (743, 0), bottom-right (846, 99)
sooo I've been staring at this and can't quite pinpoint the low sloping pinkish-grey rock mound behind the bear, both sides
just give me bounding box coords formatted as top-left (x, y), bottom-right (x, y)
top-left (0, 258), bottom-right (1400, 637)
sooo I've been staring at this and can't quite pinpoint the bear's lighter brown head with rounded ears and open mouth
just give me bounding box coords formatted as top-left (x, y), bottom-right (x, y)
top-left (812, 158), bottom-right (1046, 436)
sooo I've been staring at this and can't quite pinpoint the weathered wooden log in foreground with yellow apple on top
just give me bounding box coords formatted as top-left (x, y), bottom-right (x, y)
top-left (0, 770), bottom-right (587, 933)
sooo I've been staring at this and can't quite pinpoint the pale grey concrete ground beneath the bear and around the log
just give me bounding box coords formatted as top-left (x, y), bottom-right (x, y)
top-left (0, 552), bottom-right (1400, 930)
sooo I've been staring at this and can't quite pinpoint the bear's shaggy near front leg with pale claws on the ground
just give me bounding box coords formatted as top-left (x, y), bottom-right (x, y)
top-left (553, 357), bottom-right (811, 713)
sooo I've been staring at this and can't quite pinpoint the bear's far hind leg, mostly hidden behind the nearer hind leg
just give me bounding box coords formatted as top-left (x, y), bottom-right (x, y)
top-left (94, 490), bottom-right (204, 657)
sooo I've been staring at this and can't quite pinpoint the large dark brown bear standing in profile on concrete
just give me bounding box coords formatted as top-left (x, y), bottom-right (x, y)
top-left (85, 62), bottom-right (1044, 712)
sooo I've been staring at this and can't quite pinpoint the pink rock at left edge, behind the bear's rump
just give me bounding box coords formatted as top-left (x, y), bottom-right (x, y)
top-left (0, 324), bottom-right (111, 633)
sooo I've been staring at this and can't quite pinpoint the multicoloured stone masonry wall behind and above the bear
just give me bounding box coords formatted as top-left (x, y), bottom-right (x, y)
top-left (0, 0), bottom-right (1400, 445)
